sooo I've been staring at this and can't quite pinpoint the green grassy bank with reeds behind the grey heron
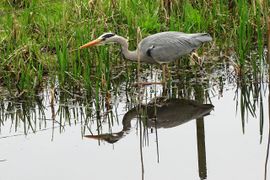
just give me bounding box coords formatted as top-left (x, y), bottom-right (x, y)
top-left (0, 0), bottom-right (269, 94)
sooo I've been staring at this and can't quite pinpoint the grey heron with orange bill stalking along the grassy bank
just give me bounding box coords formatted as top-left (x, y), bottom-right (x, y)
top-left (80, 31), bottom-right (212, 83)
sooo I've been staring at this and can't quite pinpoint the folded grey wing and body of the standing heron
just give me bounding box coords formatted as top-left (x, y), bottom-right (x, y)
top-left (141, 33), bottom-right (210, 63)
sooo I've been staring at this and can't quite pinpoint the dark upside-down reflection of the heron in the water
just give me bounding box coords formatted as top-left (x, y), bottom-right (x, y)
top-left (85, 98), bottom-right (214, 143)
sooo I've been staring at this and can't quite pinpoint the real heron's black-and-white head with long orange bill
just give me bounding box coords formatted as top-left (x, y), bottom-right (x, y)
top-left (80, 33), bottom-right (117, 49)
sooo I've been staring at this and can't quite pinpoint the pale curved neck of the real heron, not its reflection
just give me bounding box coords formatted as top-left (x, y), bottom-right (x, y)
top-left (115, 36), bottom-right (138, 61)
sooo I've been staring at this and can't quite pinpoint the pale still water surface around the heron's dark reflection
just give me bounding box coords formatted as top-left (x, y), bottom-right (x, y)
top-left (0, 67), bottom-right (270, 180)
